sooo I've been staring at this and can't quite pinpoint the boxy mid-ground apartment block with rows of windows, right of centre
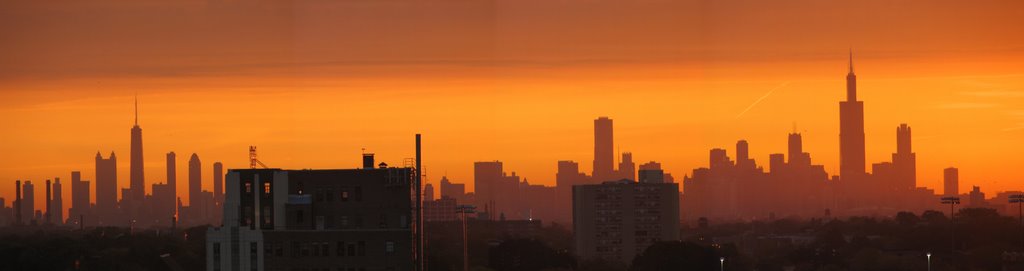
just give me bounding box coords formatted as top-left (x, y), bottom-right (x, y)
top-left (572, 180), bottom-right (679, 263)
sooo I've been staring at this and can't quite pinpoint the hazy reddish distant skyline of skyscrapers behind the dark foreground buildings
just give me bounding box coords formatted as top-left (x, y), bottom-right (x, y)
top-left (0, 53), bottom-right (1011, 228)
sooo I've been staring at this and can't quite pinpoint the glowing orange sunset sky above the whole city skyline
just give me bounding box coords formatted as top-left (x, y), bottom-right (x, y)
top-left (0, 0), bottom-right (1024, 214)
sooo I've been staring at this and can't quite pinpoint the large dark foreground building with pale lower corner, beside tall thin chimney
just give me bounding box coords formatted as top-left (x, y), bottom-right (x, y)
top-left (206, 162), bottom-right (419, 270)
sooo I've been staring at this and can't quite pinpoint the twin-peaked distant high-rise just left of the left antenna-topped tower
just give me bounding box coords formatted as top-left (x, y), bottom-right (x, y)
top-left (93, 152), bottom-right (118, 226)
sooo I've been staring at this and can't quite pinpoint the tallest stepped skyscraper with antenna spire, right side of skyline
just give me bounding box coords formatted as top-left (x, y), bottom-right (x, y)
top-left (839, 52), bottom-right (867, 194)
